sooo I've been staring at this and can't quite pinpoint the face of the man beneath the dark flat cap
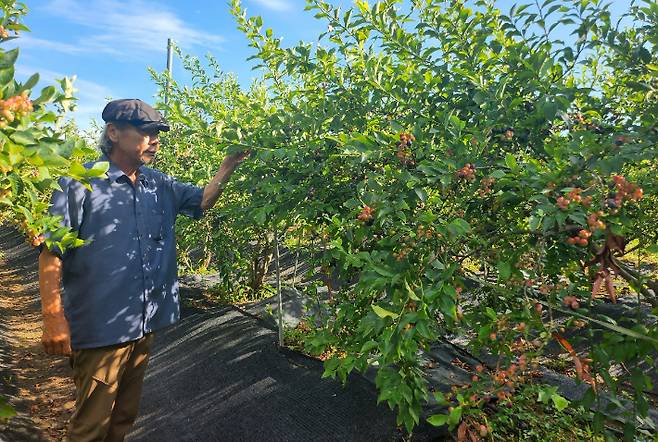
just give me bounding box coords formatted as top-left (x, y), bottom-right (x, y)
top-left (109, 124), bottom-right (160, 166)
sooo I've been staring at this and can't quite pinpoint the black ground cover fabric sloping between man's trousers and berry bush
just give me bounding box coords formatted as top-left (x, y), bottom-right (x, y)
top-left (125, 307), bottom-right (398, 441)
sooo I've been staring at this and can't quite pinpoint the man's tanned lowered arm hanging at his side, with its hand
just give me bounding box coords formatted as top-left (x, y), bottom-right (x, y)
top-left (39, 247), bottom-right (71, 356)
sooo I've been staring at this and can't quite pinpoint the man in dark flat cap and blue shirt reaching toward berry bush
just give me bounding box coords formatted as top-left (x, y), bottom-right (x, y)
top-left (39, 99), bottom-right (248, 442)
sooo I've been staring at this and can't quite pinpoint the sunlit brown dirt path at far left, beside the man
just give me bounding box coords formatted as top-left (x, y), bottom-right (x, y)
top-left (0, 227), bottom-right (74, 441)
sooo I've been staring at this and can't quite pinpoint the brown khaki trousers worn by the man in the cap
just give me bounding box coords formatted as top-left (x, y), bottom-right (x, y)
top-left (65, 333), bottom-right (153, 442)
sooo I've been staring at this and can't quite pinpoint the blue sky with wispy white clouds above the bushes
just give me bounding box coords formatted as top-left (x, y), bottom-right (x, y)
top-left (9, 0), bottom-right (627, 128)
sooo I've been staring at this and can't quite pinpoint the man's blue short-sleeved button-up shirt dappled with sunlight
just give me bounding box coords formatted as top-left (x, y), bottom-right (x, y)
top-left (50, 157), bottom-right (203, 349)
